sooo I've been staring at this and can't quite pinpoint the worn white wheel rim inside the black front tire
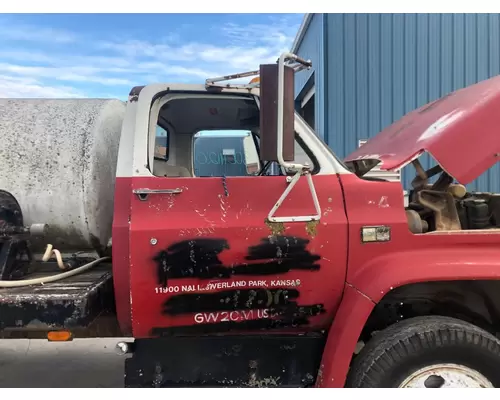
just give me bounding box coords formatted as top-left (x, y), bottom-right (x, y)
top-left (399, 364), bottom-right (494, 388)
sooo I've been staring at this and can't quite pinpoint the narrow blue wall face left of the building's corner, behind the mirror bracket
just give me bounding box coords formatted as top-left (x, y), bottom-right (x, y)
top-left (295, 14), bottom-right (326, 138)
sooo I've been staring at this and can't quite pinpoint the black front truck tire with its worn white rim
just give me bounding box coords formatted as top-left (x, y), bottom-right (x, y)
top-left (346, 316), bottom-right (500, 388)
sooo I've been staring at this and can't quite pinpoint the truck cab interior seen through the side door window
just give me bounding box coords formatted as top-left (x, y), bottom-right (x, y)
top-left (149, 93), bottom-right (311, 177)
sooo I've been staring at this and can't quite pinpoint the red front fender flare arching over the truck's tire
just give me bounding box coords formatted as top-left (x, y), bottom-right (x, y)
top-left (316, 246), bottom-right (500, 388)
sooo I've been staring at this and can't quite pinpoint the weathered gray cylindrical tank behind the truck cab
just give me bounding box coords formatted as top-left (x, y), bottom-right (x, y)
top-left (0, 99), bottom-right (126, 251)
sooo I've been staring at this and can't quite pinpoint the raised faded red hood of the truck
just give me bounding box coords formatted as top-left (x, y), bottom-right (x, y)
top-left (345, 76), bottom-right (500, 185)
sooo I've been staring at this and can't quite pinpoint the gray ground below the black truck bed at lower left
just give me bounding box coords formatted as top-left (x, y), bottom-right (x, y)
top-left (0, 338), bottom-right (125, 388)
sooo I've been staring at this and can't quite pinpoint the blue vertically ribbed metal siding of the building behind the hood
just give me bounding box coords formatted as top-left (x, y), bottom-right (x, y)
top-left (296, 14), bottom-right (500, 192)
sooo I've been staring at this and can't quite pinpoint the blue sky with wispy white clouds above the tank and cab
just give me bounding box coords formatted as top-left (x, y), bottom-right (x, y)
top-left (0, 14), bottom-right (303, 100)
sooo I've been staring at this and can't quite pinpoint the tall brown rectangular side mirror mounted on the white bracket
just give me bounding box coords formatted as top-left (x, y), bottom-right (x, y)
top-left (259, 64), bottom-right (295, 162)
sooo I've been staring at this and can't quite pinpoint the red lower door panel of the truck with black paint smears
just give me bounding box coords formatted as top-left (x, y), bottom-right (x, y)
top-left (130, 126), bottom-right (347, 338)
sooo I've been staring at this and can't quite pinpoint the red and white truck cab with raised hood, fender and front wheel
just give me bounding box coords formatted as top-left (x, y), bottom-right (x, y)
top-left (0, 54), bottom-right (500, 387)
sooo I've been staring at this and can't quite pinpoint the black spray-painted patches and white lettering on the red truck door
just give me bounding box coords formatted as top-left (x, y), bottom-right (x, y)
top-left (150, 236), bottom-right (325, 332)
